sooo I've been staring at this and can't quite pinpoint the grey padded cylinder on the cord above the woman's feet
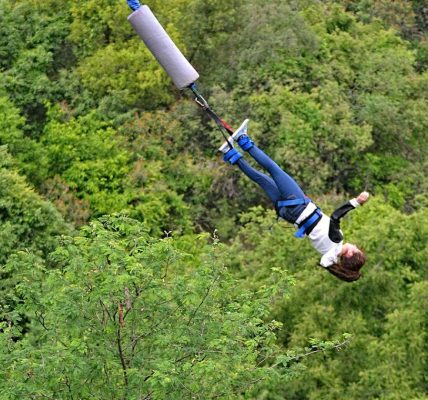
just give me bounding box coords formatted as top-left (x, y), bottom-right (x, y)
top-left (128, 6), bottom-right (199, 89)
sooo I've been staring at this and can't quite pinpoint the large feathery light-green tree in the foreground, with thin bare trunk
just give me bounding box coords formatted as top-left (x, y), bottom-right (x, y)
top-left (0, 216), bottom-right (288, 399)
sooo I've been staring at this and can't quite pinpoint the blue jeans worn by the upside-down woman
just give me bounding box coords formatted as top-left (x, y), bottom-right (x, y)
top-left (237, 145), bottom-right (306, 223)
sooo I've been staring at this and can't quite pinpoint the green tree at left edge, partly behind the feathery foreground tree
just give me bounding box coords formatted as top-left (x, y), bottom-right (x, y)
top-left (0, 146), bottom-right (73, 327)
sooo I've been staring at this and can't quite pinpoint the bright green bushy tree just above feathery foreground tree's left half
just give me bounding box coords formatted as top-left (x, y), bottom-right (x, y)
top-left (41, 107), bottom-right (130, 215)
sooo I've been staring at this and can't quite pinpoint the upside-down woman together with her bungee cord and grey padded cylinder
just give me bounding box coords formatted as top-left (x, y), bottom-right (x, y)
top-left (127, 0), bottom-right (369, 282)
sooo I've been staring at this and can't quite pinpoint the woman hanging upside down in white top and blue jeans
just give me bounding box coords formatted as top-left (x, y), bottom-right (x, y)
top-left (219, 119), bottom-right (369, 282)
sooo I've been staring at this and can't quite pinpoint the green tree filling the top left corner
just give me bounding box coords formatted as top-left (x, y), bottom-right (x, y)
top-left (0, 0), bottom-right (74, 128)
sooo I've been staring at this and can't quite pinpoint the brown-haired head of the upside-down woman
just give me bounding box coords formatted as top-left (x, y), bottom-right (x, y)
top-left (327, 243), bottom-right (366, 282)
